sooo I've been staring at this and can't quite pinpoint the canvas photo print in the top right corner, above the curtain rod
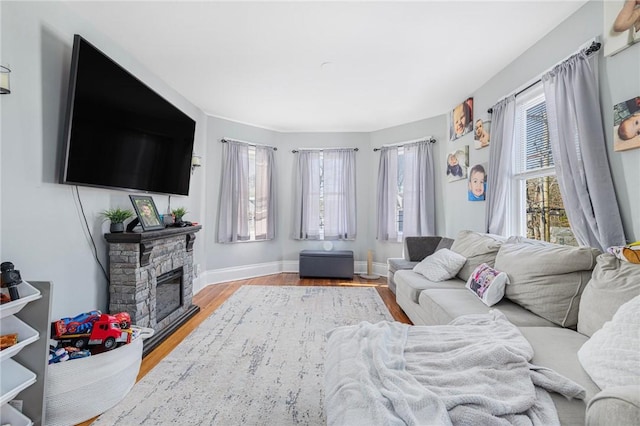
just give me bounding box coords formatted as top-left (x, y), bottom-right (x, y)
top-left (602, 0), bottom-right (640, 56)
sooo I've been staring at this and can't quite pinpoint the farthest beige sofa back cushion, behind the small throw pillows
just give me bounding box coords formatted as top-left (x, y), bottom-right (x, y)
top-left (451, 230), bottom-right (507, 282)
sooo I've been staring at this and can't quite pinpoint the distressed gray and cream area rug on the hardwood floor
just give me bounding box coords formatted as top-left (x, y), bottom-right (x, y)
top-left (92, 286), bottom-right (393, 426)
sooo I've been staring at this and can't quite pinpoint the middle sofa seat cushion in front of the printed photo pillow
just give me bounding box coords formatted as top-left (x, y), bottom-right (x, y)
top-left (418, 288), bottom-right (554, 327)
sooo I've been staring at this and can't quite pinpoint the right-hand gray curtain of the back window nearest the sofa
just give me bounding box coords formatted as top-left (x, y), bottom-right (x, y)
top-left (402, 141), bottom-right (436, 237)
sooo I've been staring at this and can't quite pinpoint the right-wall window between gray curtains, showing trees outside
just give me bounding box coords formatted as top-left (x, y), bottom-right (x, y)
top-left (513, 85), bottom-right (578, 245)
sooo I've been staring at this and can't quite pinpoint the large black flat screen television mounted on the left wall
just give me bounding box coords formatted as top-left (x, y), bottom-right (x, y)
top-left (61, 34), bottom-right (195, 195)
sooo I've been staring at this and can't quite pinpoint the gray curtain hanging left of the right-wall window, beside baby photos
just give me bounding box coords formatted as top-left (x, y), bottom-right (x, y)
top-left (485, 95), bottom-right (516, 235)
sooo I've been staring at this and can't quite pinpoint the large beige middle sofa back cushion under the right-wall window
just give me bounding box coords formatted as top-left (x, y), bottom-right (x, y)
top-left (495, 240), bottom-right (600, 327)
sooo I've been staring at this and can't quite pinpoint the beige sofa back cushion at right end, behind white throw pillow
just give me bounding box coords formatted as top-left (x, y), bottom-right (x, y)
top-left (578, 253), bottom-right (640, 336)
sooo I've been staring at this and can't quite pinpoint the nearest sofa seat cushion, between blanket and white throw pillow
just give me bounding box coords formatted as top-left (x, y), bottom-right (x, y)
top-left (520, 327), bottom-right (600, 425)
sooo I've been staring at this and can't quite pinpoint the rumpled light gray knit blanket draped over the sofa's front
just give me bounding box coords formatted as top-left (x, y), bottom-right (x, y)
top-left (325, 310), bottom-right (585, 426)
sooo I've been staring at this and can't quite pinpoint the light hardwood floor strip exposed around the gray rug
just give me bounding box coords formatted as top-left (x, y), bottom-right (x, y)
top-left (80, 273), bottom-right (411, 426)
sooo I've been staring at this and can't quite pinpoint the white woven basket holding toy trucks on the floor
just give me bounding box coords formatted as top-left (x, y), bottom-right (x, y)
top-left (44, 327), bottom-right (153, 426)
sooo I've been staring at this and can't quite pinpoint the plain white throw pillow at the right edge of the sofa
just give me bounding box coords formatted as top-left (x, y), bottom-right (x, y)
top-left (578, 296), bottom-right (640, 389)
